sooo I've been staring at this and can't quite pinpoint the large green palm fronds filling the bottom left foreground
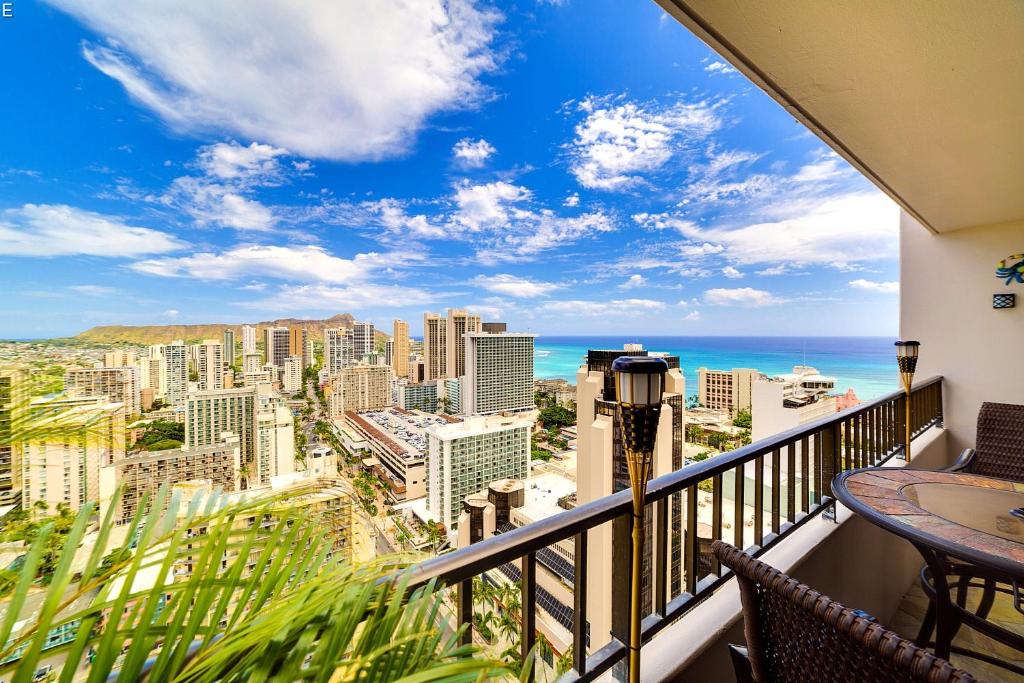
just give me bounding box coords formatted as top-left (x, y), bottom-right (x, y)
top-left (0, 488), bottom-right (520, 681)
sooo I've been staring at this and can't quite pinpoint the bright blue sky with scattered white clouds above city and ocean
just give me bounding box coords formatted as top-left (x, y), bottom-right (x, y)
top-left (0, 0), bottom-right (898, 338)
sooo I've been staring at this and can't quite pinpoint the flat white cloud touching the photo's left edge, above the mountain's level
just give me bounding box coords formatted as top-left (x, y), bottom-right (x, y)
top-left (0, 204), bottom-right (185, 257)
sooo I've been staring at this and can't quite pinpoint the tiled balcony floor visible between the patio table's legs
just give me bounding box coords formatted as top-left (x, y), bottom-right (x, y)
top-left (886, 582), bottom-right (1024, 683)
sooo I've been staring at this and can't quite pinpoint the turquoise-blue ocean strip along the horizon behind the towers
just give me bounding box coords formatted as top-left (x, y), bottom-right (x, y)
top-left (534, 335), bottom-right (900, 400)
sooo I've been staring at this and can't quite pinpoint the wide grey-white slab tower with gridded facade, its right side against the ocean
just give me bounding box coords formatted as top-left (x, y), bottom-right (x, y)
top-left (461, 332), bottom-right (537, 415)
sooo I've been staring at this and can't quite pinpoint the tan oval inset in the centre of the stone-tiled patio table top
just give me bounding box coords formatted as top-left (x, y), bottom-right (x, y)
top-left (900, 482), bottom-right (1024, 543)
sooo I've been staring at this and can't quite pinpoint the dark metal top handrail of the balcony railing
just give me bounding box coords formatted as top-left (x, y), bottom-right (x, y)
top-left (411, 375), bottom-right (942, 585)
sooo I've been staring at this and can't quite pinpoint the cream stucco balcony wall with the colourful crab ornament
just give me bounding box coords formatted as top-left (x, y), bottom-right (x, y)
top-left (900, 212), bottom-right (1024, 450)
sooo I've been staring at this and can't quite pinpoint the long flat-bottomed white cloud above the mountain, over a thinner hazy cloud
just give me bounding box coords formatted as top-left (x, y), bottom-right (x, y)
top-left (130, 245), bottom-right (393, 284)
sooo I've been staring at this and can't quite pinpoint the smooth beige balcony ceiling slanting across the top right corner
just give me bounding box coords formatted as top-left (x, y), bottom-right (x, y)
top-left (656, 0), bottom-right (1024, 232)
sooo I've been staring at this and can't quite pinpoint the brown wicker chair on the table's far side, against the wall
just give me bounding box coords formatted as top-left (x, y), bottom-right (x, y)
top-left (948, 403), bottom-right (1024, 481)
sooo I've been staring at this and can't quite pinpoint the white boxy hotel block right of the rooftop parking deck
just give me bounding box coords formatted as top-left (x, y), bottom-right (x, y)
top-left (427, 416), bottom-right (534, 528)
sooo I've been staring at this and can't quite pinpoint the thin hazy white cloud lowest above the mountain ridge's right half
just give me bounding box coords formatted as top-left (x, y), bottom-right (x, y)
top-left (251, 283), bottom-right (436, 312)
